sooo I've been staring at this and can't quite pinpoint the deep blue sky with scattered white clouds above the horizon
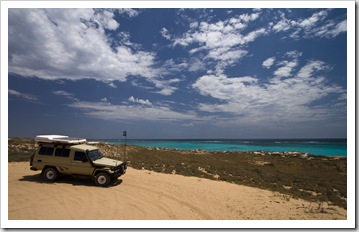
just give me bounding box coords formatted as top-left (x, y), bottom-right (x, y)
top-left (8, 8), bottom-right (347, 139)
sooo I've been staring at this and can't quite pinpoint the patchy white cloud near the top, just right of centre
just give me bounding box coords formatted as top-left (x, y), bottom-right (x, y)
top-left (172, 12), bottom-right (266, 73)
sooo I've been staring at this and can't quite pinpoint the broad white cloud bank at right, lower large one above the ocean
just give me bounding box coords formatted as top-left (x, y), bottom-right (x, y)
top-left (193, 57), bottom-right (346, 123)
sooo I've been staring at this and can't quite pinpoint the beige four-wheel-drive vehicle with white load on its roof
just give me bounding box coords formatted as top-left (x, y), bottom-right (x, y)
top-left (30, 135), bottom-right (127, 186)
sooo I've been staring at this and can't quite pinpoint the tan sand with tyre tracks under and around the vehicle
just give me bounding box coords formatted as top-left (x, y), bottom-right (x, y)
top-left (8, 162), bottom-right (347, 220)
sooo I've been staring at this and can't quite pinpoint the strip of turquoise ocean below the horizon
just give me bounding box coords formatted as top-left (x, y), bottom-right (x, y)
top-left (101, 139), bottom-right (347, 156)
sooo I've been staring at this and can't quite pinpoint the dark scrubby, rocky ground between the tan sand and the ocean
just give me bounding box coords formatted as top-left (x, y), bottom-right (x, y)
top-left (8, 138), bottom-right (347, 209)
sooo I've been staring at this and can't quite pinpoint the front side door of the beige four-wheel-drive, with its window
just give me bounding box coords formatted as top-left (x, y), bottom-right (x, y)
top-left (71, 151), bottom-right (93, 176)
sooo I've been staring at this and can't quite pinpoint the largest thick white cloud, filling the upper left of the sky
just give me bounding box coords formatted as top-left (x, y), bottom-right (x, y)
top-left (9, 8), bottom-right (179, 94)
